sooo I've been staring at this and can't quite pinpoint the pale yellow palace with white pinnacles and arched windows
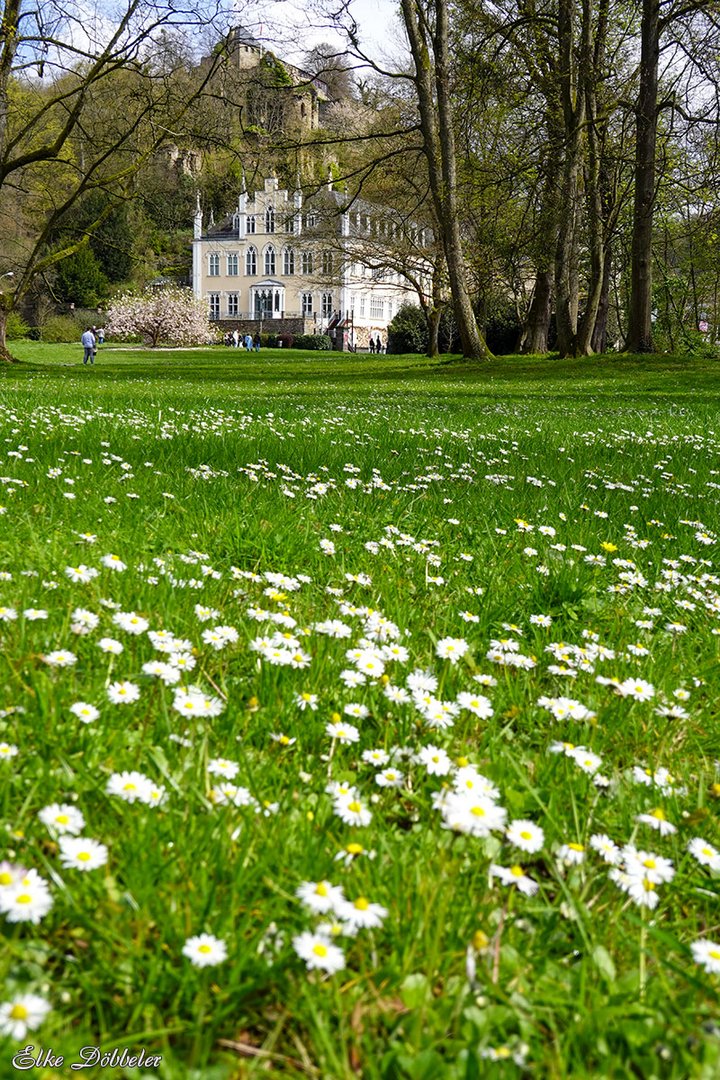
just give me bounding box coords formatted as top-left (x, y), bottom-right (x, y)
top-left (192, 177), bottom-right (422, 348)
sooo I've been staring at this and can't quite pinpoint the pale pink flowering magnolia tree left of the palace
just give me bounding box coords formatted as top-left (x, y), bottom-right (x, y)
top-left (107, 287), bottom-right (215, 348)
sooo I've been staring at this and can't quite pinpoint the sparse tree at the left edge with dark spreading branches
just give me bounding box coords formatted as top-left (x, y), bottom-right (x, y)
top-left (0, 0), bottom-right (235, 360)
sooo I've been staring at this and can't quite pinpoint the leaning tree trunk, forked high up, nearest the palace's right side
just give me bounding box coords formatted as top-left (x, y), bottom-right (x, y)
top-left (402, 0), bottom-right (491, 360)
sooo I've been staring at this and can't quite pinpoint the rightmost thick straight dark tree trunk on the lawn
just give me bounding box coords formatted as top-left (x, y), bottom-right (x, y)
top-left (627, 0), bottom-right (660, 352)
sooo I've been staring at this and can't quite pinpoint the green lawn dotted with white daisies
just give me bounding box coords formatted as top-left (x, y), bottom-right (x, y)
top-left (0, 343), bottom-right (720, 1080)
